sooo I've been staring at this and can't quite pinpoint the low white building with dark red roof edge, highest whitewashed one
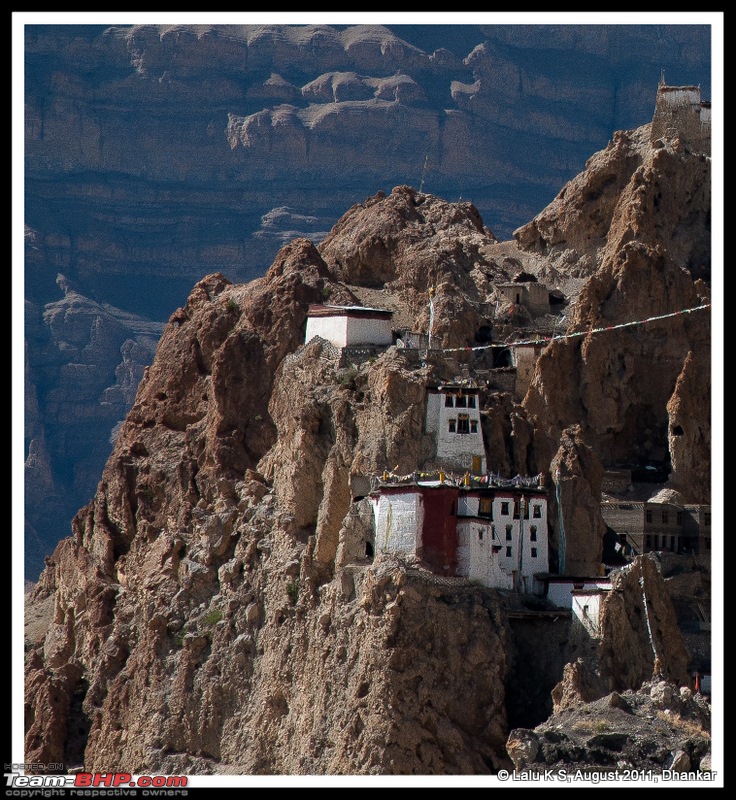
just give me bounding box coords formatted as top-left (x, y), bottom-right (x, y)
top-left (304, 304), bottom-right (394, 347)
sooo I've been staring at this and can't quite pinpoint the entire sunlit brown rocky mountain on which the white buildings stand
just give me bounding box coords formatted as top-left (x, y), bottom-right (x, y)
top-left (25, 86), bottom-right (709, 775)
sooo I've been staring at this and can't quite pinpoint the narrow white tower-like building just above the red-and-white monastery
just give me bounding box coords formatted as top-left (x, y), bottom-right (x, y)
top-left (425, 383), bottom-right (486, 475)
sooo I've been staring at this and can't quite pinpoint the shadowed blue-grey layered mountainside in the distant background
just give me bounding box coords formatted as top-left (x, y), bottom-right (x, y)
top-left (24, 25), bottom-right (711, 580)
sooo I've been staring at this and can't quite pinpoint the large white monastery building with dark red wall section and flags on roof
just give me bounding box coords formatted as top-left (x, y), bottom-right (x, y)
top-left (371, 481), bottom-right (549, 593)
